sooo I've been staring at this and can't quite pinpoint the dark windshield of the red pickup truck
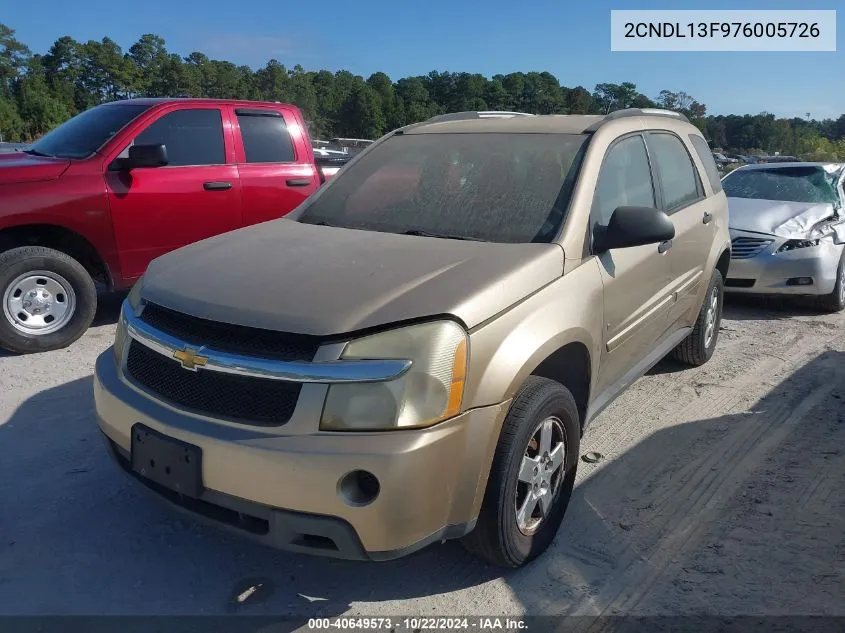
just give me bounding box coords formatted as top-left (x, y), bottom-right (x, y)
top-left (27, 103), bottom-right (150, 158)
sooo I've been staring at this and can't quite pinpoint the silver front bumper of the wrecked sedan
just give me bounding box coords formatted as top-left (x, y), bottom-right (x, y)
top-left (725, 238), bottom-right (845, 295)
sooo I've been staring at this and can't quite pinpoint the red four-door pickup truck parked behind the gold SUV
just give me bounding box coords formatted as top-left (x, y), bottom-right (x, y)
top-left (0, 99), bottom-right (337, 353)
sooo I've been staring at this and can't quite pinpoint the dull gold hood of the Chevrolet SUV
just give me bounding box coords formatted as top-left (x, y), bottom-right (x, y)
top-left (141, 219), bottom-right (564, 336)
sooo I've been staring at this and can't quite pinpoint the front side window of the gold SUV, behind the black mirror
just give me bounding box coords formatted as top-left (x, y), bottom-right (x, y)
top-left (593, 135), bottom-right (657, 226)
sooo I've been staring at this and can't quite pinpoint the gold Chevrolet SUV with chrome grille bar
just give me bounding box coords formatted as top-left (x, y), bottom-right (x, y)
top-left (94, 110), bottom-right (730, 567)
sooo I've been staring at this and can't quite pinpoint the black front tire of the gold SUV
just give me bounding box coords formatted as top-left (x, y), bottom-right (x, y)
top-left (462, 376), bottom-right (581, 568)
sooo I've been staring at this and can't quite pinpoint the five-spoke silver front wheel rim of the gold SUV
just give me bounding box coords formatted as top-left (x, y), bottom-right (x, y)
top-left (515, 417), bottom-right (566, 536)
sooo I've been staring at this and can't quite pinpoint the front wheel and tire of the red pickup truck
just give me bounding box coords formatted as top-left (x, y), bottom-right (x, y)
top-left (0, 246), bottom-right (97, 354)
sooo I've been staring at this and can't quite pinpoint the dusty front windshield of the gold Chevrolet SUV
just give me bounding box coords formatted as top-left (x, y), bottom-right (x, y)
top-left (299, 133), bottom-right (587, 243)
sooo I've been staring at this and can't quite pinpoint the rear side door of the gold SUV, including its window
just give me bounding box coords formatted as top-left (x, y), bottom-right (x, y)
top-left (646, 131), bottom-right (717, 328)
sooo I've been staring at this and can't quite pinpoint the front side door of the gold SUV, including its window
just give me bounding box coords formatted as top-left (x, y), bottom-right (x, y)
top-left (590, 133), bottom-right (672, 393)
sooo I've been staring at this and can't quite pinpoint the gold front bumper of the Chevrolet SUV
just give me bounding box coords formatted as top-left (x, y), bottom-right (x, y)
top-left (94, 349), bottom-right (507, 560)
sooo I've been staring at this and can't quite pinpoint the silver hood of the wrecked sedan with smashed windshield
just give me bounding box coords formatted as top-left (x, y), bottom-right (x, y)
top-left (728, 198), bottom-right (837, 239)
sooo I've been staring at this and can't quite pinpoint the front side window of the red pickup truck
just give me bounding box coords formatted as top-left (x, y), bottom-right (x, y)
top-left (134, 108), bottom-right (226, 167)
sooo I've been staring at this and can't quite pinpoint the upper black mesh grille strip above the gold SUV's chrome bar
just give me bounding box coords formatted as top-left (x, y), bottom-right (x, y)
top-left (141, 303), bottom-right (323, 361)
